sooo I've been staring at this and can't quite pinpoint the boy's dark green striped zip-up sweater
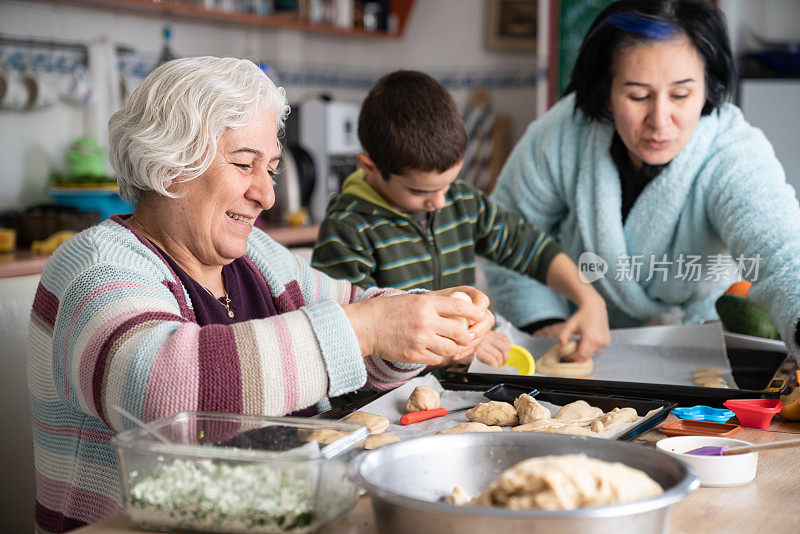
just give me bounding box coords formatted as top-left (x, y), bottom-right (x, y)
top-left (312, 171), bottom-right (561, 290)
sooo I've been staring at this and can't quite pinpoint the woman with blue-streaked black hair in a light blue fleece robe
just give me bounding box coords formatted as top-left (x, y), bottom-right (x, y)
top-left (486, 0), bottom-right (800, 360)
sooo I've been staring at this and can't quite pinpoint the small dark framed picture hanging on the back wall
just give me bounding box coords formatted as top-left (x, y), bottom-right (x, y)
top-left (486, 0), bottom-right (546, 53)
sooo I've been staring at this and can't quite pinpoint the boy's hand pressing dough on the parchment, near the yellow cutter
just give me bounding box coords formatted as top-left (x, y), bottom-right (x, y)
top-left (556, 296), bottom-right (611, 361)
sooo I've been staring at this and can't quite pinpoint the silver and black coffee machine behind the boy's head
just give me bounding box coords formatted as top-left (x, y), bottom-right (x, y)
top-left (286, 97), bottom-right (361, 222)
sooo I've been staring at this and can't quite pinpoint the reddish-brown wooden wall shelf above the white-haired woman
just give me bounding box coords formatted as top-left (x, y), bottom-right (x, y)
top-left (46, 0), bottom-right (415, 39)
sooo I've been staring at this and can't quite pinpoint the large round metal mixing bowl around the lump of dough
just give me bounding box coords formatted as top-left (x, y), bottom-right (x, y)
top-left (349, 432), bottom-right (699, 534)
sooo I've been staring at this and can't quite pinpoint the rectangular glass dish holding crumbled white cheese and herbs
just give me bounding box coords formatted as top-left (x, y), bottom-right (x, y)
top-left (111, 412), bottom-right (369, 533)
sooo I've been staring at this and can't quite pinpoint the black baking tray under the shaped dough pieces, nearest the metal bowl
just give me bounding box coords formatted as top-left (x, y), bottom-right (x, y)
top-left (316, 384), bottom-right (678, 441)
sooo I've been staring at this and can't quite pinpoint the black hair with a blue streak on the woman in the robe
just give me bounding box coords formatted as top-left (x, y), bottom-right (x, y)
top-left (564, 0), bottom-right (736, 120)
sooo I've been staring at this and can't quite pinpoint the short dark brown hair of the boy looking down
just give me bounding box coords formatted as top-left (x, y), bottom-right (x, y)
top-left (358, 70), bottom-right (467, 180)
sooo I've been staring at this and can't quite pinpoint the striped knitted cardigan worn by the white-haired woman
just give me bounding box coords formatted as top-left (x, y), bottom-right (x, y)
top-left (28, 217), bottom-right (423, 532)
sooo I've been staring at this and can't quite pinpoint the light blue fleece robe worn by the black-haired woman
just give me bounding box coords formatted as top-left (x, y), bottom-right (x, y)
top-left (485, 95), bottom-right (800, 355)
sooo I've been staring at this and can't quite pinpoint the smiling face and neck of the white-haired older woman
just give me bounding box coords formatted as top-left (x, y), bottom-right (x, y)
top-left (167, 112), bottom-right (280, 265)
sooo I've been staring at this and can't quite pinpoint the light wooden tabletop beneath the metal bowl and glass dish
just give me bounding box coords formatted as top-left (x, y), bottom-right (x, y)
top-left (75, 415), bottom-right (800, 534)
